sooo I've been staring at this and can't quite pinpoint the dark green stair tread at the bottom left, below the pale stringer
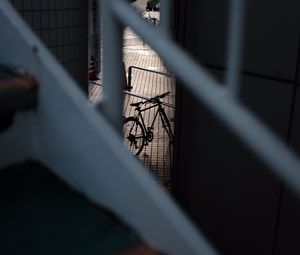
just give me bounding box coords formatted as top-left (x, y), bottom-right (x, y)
top-left (0, 162), bottom-right (140, 255)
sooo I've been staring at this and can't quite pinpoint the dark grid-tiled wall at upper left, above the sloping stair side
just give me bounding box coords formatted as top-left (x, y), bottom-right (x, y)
top-left (10, 0), bottom-right (88, 92)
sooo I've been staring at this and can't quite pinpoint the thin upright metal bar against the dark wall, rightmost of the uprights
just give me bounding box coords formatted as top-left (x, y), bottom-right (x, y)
top-left (226, 0), bottom-right (246, 97)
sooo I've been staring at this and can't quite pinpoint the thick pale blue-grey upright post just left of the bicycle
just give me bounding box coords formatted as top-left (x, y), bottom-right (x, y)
top-left (98, 0), bottom-right (123, 131)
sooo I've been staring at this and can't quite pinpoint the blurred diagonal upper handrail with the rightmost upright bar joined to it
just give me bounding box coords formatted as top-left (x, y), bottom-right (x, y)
top-left (102, 0), bottom-right (300, 195)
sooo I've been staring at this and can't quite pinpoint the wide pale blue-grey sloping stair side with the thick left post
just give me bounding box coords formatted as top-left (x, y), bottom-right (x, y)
top-left (0, 0), bottom-right (216, 255)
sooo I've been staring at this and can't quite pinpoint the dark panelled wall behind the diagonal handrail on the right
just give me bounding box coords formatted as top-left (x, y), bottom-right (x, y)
top-left (175, 0), bottom-right (300, 255)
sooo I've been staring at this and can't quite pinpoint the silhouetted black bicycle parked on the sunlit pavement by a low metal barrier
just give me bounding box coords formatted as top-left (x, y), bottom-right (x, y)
top-left (123, 92), bottom-right (174, 156)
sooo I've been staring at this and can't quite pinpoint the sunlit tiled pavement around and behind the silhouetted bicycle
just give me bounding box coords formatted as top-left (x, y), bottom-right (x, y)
top-left (89, 19), bottom-right (175, 189)
